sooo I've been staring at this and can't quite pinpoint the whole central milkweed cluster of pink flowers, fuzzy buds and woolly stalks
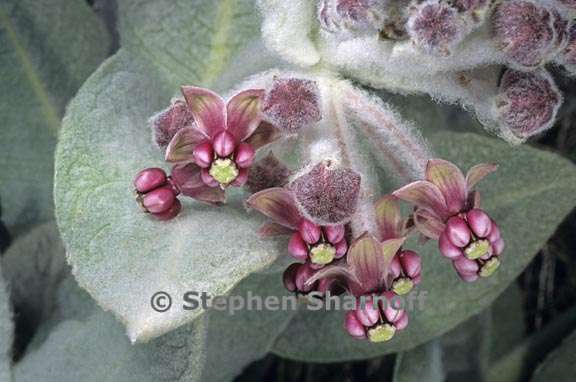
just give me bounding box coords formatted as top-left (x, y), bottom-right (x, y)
top-left (134, 69), bottom-right (508, 342)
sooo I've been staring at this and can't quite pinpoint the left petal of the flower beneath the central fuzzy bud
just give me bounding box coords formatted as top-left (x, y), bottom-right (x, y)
top-left (246, 187), bottom-right (301, 230)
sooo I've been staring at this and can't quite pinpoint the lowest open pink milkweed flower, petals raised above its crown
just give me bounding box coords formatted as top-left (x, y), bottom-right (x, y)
top-left (305, 233), bottom-right (408, 342)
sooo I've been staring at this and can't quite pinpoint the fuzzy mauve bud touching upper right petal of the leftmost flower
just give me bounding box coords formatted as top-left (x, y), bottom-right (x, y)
top-left (262, 78), bottom-right (322, 133)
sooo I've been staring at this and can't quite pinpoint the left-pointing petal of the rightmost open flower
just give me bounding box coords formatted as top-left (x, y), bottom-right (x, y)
top-left (392, 180), bottom-right (448, 218)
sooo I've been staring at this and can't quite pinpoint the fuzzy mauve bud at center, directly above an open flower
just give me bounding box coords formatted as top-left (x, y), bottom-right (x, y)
top-left (289, 161), bottom-right (360, 225)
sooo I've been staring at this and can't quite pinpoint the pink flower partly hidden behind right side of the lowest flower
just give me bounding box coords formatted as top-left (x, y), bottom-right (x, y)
top-left (375, 195), bottom-right (422, 295)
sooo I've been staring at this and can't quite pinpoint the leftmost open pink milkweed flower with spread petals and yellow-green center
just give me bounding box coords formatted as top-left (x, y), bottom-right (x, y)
top-left (165, 86), bottom-right (279, 188)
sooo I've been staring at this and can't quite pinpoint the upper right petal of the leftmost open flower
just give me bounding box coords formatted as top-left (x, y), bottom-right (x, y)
top-left (226, 89), bottom-right (264, 142)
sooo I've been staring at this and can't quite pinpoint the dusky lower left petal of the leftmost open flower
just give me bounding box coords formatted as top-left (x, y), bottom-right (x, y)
top-left (170, 163), bottom-right (226, 204)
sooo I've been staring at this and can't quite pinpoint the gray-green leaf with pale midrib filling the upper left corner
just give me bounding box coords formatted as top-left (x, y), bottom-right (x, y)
top-left (0, 0), bottom-right (109, 232)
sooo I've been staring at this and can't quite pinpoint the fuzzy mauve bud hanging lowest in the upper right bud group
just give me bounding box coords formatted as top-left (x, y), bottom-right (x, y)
top-left (495, 70), bottom-right (562, 138)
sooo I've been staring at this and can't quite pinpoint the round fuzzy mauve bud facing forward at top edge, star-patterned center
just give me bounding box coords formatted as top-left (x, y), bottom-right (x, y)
top-left (406, 0), bottom-right (468, 56)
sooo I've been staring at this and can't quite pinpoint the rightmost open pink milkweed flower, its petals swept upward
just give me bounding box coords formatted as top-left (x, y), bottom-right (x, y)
top-left (393, 159), bottom-right (504, 282)
